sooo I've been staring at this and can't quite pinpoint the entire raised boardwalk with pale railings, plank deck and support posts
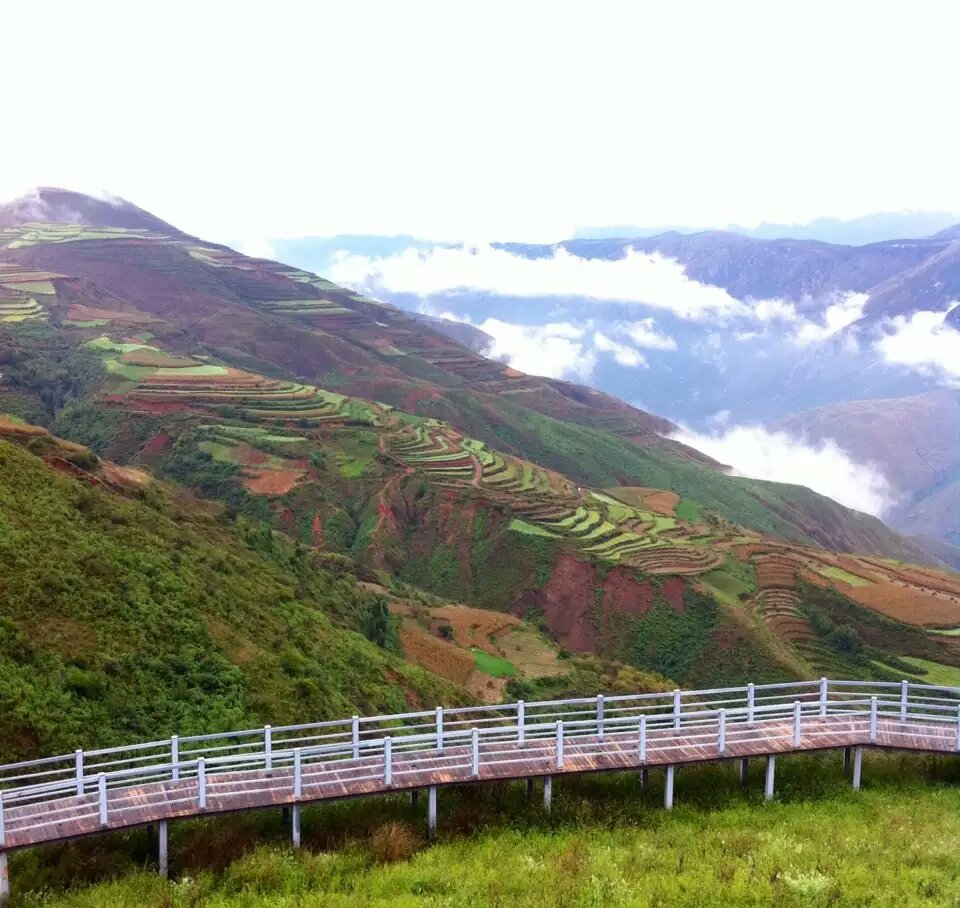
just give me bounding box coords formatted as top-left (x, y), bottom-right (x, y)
top-left (0, 679), bottom-right (960, 905)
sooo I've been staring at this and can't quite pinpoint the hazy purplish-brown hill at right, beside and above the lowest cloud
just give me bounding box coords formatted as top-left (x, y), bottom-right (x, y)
top-left (778, 388), bottom-right (960, 548)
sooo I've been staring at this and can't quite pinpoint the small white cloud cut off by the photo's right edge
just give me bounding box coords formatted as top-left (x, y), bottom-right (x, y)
top-left (876, 304), bottom-right (960, 387)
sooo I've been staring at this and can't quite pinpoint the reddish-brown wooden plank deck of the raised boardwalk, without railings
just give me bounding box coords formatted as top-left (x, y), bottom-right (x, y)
top-left (4, 716), bottom-right (957, 849)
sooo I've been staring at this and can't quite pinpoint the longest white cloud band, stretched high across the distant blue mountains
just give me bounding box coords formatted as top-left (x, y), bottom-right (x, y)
top-left (329, 245), bottom-right (789, 322)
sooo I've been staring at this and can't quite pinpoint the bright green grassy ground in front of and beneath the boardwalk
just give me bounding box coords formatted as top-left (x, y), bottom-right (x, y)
top-left (14, 755), bottom-right (960, 908)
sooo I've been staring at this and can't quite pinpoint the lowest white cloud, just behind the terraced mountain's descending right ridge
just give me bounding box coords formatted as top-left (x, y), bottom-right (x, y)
top-left (674, 426), bottom-right (896, 517)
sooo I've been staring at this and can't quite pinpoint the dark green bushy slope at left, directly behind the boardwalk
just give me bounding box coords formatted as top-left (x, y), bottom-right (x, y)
top-left (0, 436), bottom-right (466, 760)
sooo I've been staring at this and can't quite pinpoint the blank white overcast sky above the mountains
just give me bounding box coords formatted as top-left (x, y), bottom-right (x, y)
top-left (0, 0), bottom-right (960, 241)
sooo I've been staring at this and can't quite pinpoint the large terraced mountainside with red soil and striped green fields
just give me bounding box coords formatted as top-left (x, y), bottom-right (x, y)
top-left (0, 186), bottom-right (960, 712)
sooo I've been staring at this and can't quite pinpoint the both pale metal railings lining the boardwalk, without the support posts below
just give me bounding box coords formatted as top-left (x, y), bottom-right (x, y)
top-left (0, 678), bottom-right (960, 849)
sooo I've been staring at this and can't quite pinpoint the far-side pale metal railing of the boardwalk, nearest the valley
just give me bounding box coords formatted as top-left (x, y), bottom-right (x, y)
top-left (0, 678), bottom-right (960, 805)
